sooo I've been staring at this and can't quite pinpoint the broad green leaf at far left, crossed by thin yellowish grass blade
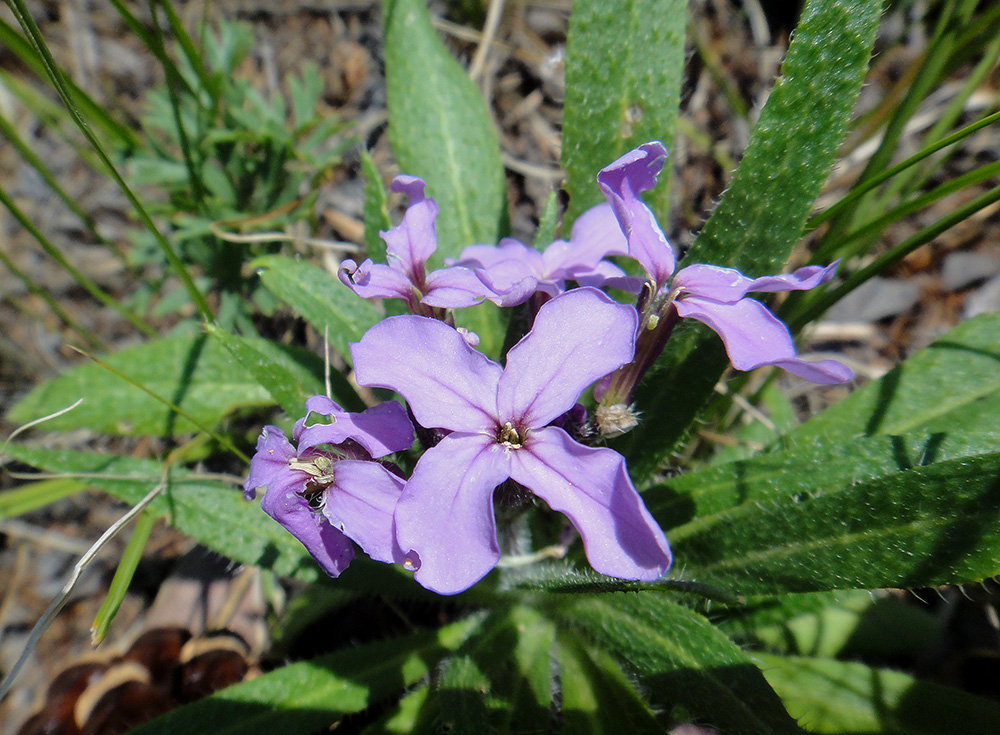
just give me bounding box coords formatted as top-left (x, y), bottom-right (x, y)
top-left (10, 335), bottom-right (271, 436)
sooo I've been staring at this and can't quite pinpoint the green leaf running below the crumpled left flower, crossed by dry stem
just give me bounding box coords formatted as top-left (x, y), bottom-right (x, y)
top-left (1, 444), bottom-right (320, 582)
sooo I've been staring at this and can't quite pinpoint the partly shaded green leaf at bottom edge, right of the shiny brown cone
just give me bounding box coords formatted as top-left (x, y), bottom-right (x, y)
top-left (130, 618), bottom-right (476, 735)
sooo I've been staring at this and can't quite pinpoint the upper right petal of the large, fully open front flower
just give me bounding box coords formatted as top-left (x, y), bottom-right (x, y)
top-left (497, 288), bottom-right (638, 426)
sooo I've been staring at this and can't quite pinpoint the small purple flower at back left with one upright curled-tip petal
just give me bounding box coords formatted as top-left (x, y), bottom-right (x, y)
top-left (338, 176), bottom-right (489, 316)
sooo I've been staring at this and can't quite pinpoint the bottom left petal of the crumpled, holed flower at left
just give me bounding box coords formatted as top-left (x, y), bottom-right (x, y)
top-left (260, 485), bottom-right (354, 577)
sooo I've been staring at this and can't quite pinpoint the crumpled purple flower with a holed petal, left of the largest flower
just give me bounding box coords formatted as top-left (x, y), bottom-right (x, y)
top-left (243, 396), bottom-right (413, 577)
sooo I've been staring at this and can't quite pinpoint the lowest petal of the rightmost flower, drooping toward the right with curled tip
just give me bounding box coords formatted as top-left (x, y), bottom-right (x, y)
top-left (674, 297), bottom-right (853, 384)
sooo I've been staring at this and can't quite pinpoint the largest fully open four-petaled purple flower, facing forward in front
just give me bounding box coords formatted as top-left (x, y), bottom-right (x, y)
top-left (351, 288), bottom-right (670, 594)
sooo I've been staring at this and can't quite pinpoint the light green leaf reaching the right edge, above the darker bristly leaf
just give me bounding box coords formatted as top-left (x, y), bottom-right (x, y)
top-left (644, 314), bottom-right (1000, 527)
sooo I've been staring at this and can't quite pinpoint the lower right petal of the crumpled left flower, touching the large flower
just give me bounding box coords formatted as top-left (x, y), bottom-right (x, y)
top-left (323, 459), bottom-right (406, 564)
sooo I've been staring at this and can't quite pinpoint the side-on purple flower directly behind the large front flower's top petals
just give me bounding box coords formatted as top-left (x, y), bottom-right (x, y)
top-left (454, 204), bottom-right (642, 306)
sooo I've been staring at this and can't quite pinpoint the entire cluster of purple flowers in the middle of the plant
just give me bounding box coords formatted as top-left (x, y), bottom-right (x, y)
top-left (245, 142), bottom-right (852, 594)
